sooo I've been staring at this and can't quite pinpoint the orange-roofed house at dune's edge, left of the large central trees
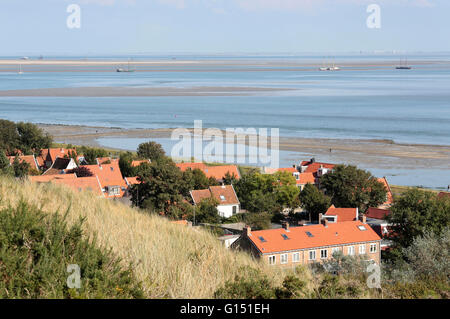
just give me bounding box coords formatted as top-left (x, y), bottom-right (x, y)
top-left (80, 161), bottom-right (127, 198)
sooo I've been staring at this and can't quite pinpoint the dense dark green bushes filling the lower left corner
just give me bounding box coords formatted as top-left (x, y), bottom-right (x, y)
top-left (0, 202), bottom-right (143, 298)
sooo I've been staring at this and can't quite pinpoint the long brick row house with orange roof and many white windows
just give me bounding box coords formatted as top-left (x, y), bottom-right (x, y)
top-left (232, 219), bottom-right (381, 267)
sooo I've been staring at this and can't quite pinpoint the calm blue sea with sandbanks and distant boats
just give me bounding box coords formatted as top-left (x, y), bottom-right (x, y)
top-left (0, 55), bottom-right (450, 187)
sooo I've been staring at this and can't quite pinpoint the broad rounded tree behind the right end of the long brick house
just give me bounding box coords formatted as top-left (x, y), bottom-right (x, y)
top-left (320, 165), bottom-right (387, 213)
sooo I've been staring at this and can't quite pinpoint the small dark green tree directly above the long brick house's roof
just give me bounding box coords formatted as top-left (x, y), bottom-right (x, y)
top-left (299, 183), bottom-right (331, 221)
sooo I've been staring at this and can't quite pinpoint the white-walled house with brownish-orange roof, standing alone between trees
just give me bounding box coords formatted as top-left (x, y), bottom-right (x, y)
top-left (191, 185), bottom-right (241, 218)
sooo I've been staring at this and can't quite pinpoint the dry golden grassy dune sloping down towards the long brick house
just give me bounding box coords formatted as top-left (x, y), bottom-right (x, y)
top-left (0, 177), bottom-right (283, 298)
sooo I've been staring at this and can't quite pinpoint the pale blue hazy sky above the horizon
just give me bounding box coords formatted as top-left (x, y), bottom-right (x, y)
top-left (0, 0), bottom-right (450, 56)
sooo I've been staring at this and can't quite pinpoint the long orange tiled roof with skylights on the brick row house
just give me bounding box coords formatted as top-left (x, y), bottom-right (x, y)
top-left (248, 221), bottom-right (381, 254)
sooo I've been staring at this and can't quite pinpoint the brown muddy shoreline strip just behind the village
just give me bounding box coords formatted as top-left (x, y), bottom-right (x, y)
top-left (36, 123), bottom-right (450, 170)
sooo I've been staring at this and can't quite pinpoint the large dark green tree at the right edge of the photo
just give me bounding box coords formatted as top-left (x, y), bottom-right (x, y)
top-left (386, 188), bottom-right (450, 254)
